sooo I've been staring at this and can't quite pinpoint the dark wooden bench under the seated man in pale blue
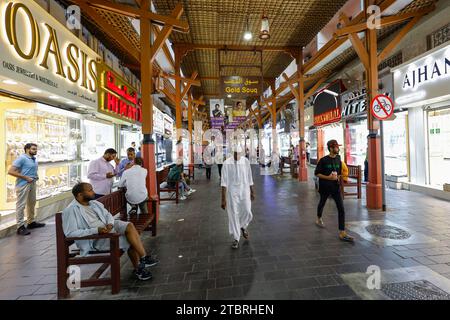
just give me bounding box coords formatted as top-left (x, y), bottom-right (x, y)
top-left (55, 191), bottom-right (158, 298)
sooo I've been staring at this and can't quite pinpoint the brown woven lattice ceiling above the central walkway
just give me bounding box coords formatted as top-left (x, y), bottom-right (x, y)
top-left (153, 0), bottom-right (346, 94)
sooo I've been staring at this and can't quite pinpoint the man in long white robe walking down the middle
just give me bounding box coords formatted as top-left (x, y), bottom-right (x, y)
top-left (221, 145), bottom-right (255, 249)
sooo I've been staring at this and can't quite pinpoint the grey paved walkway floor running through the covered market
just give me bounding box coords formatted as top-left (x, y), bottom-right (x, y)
top-left (0, 167), bottom-right (450, 300)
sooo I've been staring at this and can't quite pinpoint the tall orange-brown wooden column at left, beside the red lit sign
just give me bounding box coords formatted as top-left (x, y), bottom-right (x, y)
top-left (140, 0), bottom-right (159, 221)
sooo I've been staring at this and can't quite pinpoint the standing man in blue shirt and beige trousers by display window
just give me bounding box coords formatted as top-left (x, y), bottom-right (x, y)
top-left (8, 143), bottom-right (45, 235)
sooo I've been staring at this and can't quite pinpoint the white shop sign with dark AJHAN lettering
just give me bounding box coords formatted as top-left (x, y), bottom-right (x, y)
top-left (392, 45), bottom-right (450, 107)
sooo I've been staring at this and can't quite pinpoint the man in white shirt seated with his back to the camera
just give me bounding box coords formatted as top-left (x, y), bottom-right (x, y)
top-left (119, 158), bottom-right (148, 214)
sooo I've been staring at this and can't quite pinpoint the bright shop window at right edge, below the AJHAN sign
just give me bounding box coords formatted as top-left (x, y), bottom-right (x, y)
top-left (428, 108), bottom-right (450, 188)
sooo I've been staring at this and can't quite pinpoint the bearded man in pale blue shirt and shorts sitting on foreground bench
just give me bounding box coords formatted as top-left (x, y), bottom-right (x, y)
top-left (62, 182), bottom-right (159, 280)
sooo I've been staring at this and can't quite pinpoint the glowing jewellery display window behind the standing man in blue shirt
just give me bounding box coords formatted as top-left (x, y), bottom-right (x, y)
top-left (0, 98), bottom-right (82, 210)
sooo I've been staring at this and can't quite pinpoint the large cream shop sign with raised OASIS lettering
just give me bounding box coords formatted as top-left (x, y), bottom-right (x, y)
top-left (0, 0), bottom-right (99, 108)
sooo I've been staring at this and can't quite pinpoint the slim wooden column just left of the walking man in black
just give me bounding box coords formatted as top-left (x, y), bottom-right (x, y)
top-left (296, 49), bottom-right (308, 181)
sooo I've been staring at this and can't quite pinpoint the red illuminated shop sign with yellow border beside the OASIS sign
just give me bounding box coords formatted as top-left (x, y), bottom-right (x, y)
top-left (98, 65), bottom-right (142, 122)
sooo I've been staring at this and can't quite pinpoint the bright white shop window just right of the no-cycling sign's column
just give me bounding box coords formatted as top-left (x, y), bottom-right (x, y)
top-left (383, 112), bottom-right (408, 177)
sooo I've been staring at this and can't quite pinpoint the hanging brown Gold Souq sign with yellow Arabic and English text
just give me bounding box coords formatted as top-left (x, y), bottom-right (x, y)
top-left (220, 76), bottom-right (263, 97)
